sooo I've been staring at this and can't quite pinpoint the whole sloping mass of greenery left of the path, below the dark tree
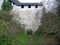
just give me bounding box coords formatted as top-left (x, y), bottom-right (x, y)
top-left (0, 11), bottom-right (29, 45)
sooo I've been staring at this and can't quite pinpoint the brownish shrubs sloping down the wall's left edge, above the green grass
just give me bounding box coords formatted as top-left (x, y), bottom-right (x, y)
top-left (0, 11), bottom-right (24, 34)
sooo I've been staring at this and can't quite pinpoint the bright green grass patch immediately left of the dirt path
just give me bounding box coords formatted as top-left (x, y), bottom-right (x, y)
top-left (12, 33), bottom-right (29, 45)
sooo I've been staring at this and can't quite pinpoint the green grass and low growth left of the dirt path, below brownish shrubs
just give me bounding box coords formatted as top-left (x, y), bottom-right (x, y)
top-left (0, 20), bottom-right (29, 45)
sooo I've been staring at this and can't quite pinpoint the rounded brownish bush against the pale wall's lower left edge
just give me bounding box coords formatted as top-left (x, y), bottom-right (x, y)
top-left (8, 21), bottom-right (24, 34)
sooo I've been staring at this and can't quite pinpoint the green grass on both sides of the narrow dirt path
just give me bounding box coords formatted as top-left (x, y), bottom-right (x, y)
top-left (0, 20), bottom-right (43, 45)
